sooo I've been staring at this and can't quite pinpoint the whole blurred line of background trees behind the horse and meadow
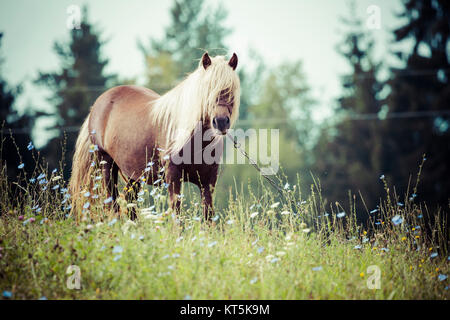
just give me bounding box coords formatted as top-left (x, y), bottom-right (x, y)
top-left (0, 0), bottom-right (450, 219)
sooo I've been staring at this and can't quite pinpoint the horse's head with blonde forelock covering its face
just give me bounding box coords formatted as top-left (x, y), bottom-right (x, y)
top-left (200, 53), bottom-right (240, 135)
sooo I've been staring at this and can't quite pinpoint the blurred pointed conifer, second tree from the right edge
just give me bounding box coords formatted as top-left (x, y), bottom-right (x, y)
top-left (312, 7), bottom-right (384, 218)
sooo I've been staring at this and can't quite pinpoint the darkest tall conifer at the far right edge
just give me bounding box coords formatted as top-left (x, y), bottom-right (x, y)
top-left (386, 0), bottom-right (450, 209)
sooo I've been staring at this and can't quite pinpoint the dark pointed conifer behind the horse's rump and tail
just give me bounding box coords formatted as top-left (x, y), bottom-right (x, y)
top-left (36, 7), bottom-right (115, 173)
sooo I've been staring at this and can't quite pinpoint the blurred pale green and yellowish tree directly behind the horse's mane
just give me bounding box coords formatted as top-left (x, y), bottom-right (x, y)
top-left (139, 0), bottom-right (230, 94)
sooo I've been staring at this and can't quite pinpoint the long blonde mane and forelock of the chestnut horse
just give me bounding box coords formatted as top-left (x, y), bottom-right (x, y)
top-left (152, 56), bottom-right (240, 153)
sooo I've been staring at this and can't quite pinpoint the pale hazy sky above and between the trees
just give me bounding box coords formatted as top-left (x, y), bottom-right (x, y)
top-left (0, 0), bottom-right (402, 146)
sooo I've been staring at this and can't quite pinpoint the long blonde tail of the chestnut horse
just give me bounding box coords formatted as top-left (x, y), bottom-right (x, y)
top-left (69, 116), bottom-right (92, 216)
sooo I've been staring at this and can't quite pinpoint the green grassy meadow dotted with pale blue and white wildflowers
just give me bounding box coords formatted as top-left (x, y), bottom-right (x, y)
top-left (0, 156), bottom-right (450, 299)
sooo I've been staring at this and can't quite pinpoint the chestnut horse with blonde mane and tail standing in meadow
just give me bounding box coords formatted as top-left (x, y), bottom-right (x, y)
top-left (69, 52), bottom-right (240, 220)
